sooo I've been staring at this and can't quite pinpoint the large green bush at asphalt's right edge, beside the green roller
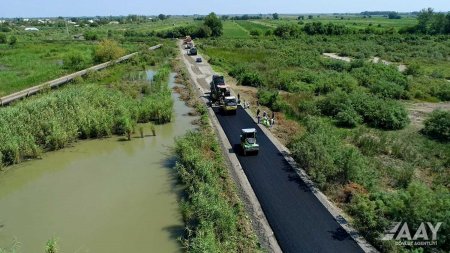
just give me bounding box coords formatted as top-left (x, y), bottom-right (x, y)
top-left (289, 117), bottom-right (376, 188)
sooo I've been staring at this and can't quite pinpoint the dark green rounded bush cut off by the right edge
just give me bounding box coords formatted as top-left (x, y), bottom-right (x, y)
top-left (422, 110), bottom-right (450, 142)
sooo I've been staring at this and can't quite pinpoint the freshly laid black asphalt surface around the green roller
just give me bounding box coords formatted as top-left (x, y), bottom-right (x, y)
top-left (214, 107), bottom-right (363, 253)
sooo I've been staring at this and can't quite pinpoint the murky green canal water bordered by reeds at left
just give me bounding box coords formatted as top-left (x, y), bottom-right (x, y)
top-left (0, 72), bottom-right (194, 253)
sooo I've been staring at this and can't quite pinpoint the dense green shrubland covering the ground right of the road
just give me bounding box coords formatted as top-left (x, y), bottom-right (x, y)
top-left (196, 10), bottom-right (450, 252)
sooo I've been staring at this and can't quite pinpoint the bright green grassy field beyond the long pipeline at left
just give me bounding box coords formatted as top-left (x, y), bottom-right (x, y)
top-left (0, 18), bottom-right (186, 97)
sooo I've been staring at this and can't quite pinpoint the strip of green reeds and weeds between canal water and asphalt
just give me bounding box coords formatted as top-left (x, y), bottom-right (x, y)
top-left (175, 125), bottom-right (260, 252)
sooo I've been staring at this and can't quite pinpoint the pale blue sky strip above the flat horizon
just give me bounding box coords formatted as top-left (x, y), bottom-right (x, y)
top-left (0, 0), bottom-right (450, 17)
